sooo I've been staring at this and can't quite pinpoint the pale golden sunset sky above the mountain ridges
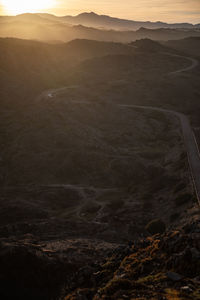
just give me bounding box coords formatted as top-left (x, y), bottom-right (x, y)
top-left (0, 0), bottom-right (200, 23)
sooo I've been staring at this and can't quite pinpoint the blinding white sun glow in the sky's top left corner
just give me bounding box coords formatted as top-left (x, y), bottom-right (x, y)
top-left (1, 0), bottom-right (55, 15)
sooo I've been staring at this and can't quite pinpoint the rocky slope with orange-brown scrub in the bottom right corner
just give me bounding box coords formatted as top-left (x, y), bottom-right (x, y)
top-left (63, 221), bottom-right (200, 300)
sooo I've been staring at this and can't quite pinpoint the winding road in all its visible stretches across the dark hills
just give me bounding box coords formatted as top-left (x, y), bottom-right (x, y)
top-left (37, 53), bottom-right (200, 205)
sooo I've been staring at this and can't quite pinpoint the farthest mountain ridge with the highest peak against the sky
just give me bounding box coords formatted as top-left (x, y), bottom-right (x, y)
top-left (61, 12), bottom-right (200, 30)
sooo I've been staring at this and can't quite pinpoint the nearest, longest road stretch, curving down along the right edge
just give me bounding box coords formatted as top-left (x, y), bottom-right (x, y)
top-left (119, 104), bottom-right (200, 205)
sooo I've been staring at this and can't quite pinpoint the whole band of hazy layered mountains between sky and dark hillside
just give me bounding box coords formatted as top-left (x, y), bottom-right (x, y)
top-left (0, 13), bottom-right (200, 43)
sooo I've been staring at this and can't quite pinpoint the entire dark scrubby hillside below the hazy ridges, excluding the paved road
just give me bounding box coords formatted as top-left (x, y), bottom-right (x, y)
top-left (0, 37), bottom-right (200, 300)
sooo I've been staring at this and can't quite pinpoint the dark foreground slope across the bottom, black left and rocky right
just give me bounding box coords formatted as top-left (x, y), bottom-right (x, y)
top-left (0, 221), bottom-right (200, 300)
